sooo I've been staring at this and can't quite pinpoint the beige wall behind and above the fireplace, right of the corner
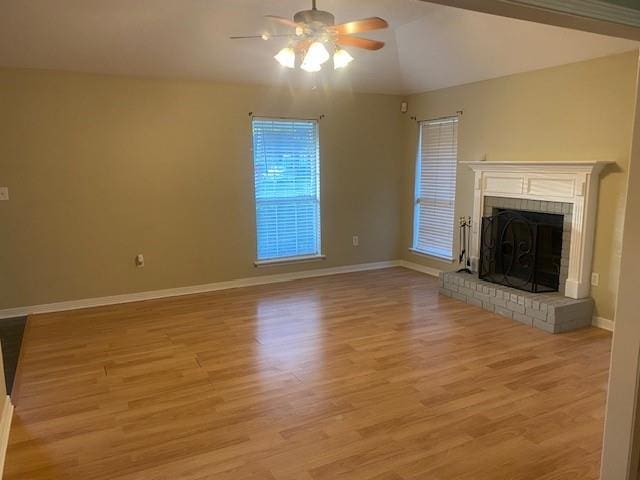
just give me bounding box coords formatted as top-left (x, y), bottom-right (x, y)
top-left (401, 52), bottom-right (637, 319)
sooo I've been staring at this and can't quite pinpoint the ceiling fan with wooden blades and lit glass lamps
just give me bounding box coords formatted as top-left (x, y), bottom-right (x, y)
top-left (230, 0), bottom-right (389, 72)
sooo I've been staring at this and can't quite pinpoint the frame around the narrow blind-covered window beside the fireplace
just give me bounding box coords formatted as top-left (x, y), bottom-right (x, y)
top-left (409, 115), bottom-right (460, 263)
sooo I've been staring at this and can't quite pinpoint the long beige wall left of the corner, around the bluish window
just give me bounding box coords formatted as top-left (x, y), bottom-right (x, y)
top-left (0, 70), bottom-right (402, 309)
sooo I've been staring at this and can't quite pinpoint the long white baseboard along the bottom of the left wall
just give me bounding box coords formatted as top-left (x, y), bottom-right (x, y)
top-left (0, 260), bottom-right (400, 319)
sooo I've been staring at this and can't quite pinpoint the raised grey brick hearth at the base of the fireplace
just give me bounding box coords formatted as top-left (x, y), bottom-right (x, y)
top-left (440, 272), bottom-right (593, 333)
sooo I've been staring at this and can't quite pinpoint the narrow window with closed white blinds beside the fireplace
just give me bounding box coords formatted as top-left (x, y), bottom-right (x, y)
top-left (412, 117), bottom-right (458, 260)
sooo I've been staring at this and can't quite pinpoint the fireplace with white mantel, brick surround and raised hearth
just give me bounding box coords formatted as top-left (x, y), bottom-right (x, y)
top-left (440, 162), bottom-right (610, 333)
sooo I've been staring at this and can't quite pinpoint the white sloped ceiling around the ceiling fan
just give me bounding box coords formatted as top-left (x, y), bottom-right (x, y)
top-left (0, 0), bottom-right (638, 93)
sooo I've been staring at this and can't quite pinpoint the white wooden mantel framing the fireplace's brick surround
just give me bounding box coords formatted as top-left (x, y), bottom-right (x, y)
top-left (461, 161), bottom-right (614, 298)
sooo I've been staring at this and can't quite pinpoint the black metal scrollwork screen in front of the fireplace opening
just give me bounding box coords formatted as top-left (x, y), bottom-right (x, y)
top-left (478, 209), bottom-right (564, 292)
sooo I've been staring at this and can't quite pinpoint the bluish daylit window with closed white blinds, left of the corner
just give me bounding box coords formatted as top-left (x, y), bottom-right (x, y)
top-left (252, 118), bottom-right (320, 263)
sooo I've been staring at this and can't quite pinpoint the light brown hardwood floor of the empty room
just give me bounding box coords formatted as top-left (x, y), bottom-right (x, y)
top-left (4, 268), bottom-right (610, 480)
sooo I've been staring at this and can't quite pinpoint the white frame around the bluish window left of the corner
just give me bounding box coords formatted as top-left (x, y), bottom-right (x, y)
top-left (251, 116), bottom-right (326, 267)
